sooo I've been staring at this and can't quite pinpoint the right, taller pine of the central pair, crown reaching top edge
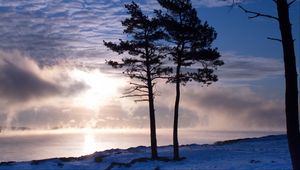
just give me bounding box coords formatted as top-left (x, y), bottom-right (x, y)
top-left (156, 0), bottom-right (223, 160)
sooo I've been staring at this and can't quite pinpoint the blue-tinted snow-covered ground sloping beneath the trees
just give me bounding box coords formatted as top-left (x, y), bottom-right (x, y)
top-left (0, 135), bottom-right (291, 170)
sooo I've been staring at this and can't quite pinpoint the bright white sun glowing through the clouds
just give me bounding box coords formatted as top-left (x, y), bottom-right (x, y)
top-left (71, 69), bottom-right (124, 110)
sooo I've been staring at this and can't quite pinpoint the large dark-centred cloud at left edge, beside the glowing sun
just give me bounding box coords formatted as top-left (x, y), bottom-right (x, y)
top-left (0, 50), bottom-right (88, 127)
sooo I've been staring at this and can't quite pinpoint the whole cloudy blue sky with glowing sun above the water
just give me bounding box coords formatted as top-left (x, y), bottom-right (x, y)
top-left (0, 0), bottom-right (300, 130)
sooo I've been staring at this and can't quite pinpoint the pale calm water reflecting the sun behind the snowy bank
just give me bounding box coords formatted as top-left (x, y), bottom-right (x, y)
top-left (0, 129), bottom-right (283, 162)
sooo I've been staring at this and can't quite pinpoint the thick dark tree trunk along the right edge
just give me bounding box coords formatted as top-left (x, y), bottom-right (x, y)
top-left (277, 0), bottom-right (300, 170)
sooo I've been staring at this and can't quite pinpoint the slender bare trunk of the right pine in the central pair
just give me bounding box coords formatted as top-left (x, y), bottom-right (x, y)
top-left (173, 65), bottom-right (180, 160)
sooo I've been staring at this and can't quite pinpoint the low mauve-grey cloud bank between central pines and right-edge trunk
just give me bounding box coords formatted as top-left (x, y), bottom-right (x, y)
top-left (178, 87), bottom-right (285, 130)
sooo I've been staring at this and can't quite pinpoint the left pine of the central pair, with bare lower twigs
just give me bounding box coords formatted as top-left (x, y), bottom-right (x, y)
top-left (104, 2), bottom-right (170, 159)
